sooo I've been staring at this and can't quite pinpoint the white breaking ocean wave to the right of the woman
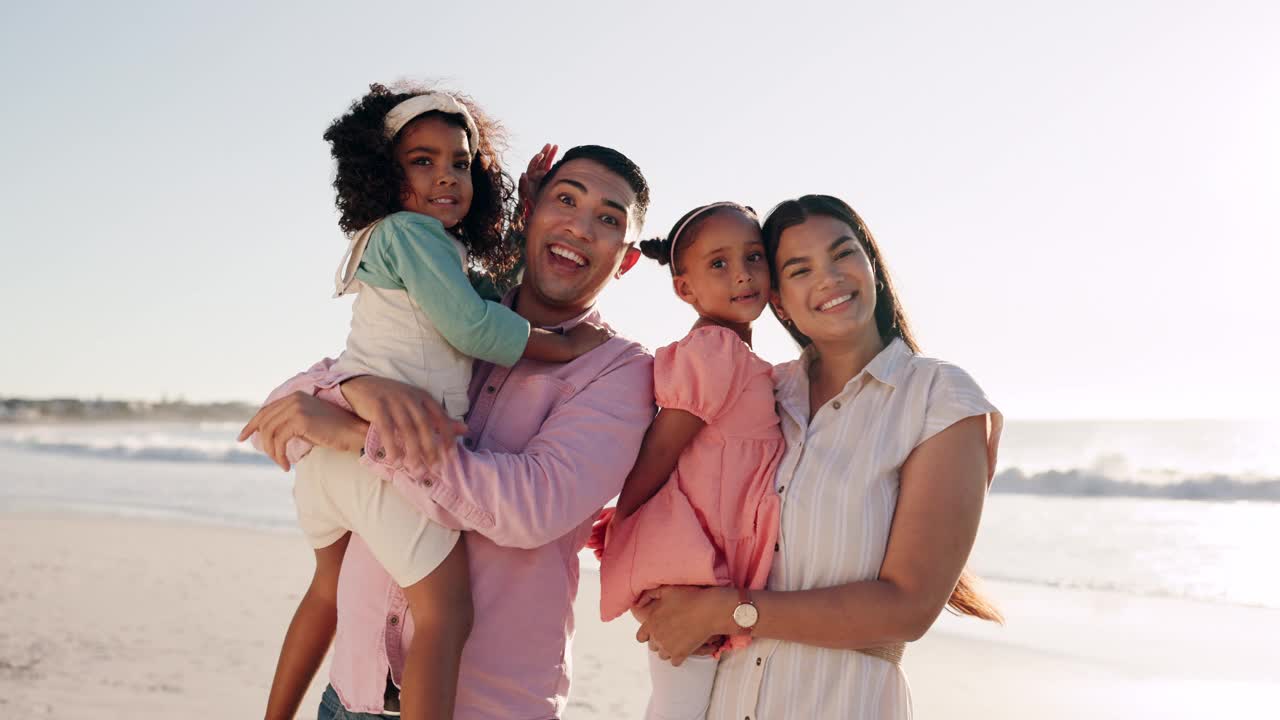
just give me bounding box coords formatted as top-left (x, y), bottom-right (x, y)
top-left (991, 468), bottom-right (1280, 502)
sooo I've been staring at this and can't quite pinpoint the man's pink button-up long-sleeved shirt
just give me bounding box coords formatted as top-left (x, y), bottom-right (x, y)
top-left (263, 298), bottom-right (654, 720)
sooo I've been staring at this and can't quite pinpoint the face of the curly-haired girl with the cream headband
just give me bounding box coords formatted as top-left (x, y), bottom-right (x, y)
top-left (396, 115), bottom-right (472, 228)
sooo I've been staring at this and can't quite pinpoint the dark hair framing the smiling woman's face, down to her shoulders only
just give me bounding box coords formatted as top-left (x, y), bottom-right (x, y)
top-left (763, 195), bottom-right (920, 352)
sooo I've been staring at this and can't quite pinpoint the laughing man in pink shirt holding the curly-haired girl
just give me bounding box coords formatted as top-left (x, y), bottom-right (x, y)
top-left (246, 146), bottom-right (654, 720)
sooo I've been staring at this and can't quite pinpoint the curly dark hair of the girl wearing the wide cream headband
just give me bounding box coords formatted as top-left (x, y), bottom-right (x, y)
top-left (324, 83), bottom-right (520, 275)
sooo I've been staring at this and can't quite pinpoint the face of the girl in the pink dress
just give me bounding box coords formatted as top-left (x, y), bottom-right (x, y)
top-left (673, 211), bottom-right (769, 324)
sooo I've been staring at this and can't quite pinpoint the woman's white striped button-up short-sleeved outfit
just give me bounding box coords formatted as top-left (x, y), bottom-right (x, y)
top-left (708, 340), bottom-right (1002, 720)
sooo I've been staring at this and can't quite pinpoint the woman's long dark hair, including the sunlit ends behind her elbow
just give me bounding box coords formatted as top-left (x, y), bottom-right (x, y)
top-left (763, 195), bottom-right (1005, 623)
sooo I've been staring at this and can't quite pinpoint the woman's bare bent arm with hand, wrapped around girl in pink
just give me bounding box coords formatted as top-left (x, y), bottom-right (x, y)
top-left (636, 415), bottom-right (989, 661)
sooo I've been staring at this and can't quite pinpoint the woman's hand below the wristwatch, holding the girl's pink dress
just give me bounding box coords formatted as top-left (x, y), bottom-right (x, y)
top-left (632, 585), bottom-right (737, 667)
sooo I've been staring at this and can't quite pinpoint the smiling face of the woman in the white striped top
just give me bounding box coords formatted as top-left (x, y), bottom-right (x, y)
top-left (773, 215), bottom-right (879, 345)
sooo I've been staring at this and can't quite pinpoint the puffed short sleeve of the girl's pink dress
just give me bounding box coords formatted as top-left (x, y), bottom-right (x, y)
top-left (653, 327), bottom-right (753, 424)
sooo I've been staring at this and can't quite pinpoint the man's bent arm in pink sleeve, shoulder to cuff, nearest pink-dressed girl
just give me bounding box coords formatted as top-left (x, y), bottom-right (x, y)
top-left (365, 350), bottom-right (654, 548)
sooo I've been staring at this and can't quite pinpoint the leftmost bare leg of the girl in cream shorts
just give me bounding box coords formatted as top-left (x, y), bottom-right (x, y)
top-left (266, 533), bottom-right (351, 720)
